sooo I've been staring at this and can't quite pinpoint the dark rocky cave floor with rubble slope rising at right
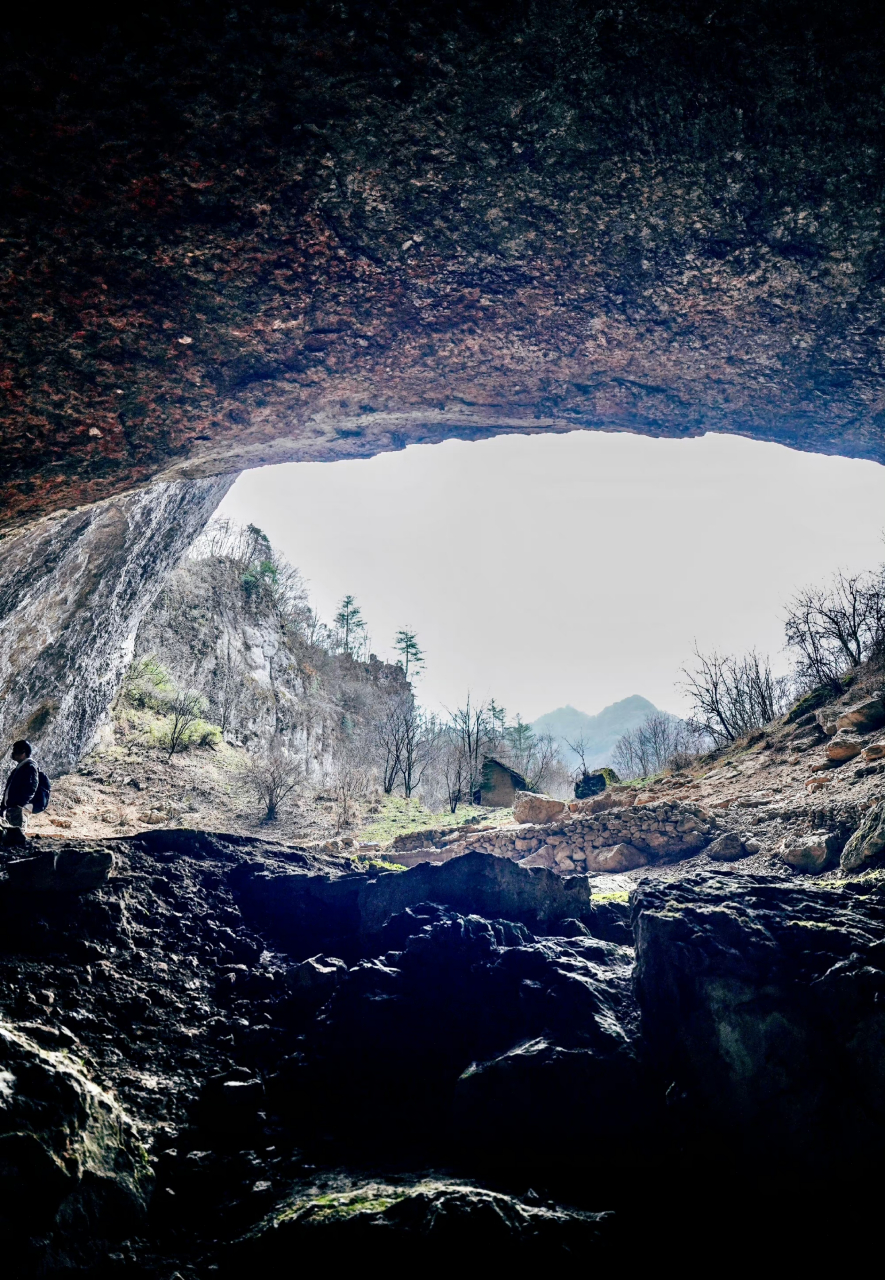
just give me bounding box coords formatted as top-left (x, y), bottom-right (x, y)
top-left (0, 689), bottom-right (885, 1280)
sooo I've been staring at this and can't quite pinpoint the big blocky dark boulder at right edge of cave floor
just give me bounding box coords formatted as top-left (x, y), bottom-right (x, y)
top-left (634, 872), bottom-right (885, 1174)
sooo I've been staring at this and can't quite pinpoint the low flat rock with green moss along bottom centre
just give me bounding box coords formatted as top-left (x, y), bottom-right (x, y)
top-left (231, 1178), bottom-right (608, 1276)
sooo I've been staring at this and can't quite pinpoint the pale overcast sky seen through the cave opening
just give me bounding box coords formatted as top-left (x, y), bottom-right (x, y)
top-left (220, 431), bottom-right (885, 721)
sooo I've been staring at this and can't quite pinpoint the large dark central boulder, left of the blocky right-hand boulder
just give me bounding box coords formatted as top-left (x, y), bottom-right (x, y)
top-left (286, 905), bottom-right (638, 1165)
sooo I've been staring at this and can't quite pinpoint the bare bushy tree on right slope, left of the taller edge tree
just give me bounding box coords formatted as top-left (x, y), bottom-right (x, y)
top-left (683, 650), bottom-right (792, 746)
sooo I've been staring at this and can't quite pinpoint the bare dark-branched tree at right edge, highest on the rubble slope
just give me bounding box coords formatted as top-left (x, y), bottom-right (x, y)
top-left (785, 570), bottom-right (885, 691)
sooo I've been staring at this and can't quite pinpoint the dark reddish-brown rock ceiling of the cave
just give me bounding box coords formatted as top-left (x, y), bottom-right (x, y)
top-left (0, 0), bottom-right (885, 527)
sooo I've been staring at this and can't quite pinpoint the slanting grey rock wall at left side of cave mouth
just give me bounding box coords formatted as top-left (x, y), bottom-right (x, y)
top-left (0, 477), bottom-right (233, 773)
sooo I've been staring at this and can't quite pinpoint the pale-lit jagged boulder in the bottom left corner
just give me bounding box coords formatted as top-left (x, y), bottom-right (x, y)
top-left (0, 1024), bottom-right (152, 1263)
